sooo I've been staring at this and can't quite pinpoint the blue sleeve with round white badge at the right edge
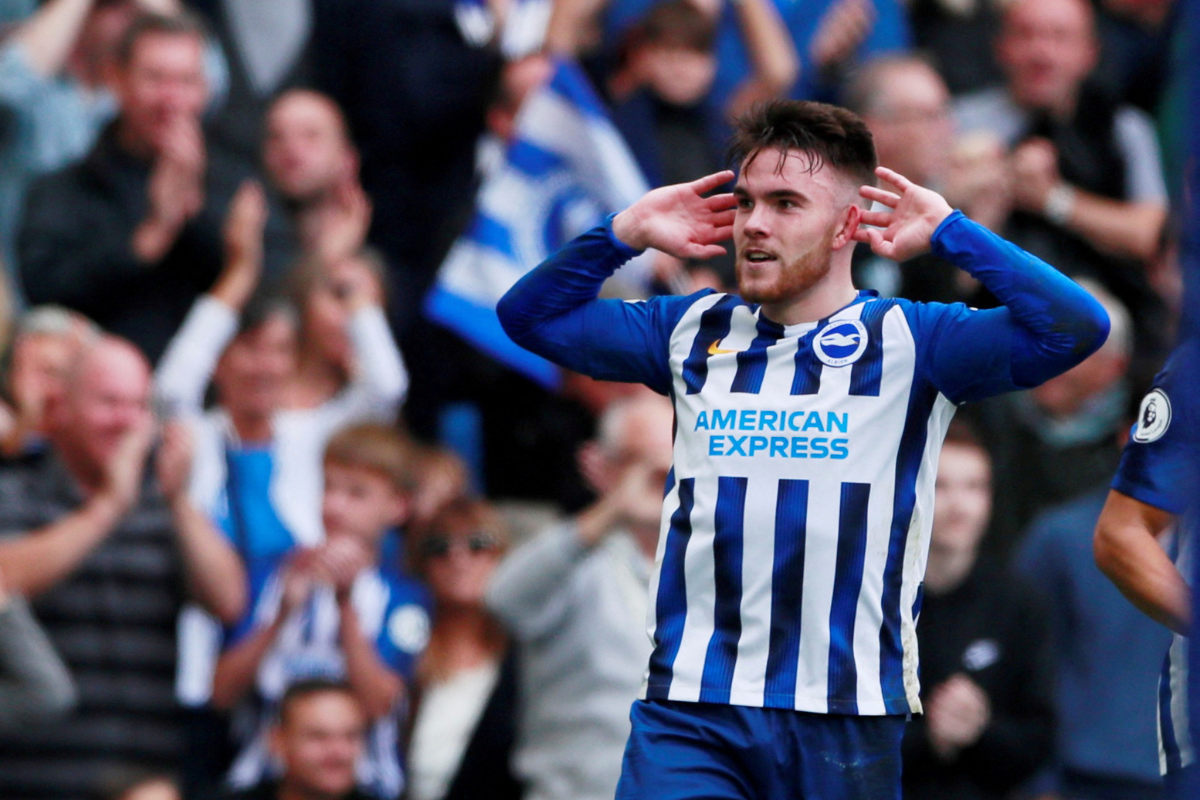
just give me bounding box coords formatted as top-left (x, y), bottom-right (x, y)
top-left (1112, 345), bottom-right (1200, 515)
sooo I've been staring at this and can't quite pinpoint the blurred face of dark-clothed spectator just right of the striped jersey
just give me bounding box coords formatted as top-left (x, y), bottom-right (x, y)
top-left (931, 444), bottom-right (991, 554)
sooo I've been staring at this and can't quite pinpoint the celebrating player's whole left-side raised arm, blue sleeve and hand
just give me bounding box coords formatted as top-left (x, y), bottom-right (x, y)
top-left (496, 172), bottom-right (733, 392)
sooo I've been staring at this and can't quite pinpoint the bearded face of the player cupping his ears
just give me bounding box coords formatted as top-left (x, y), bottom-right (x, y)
top-left (733, 150), bottom-right (858, 303)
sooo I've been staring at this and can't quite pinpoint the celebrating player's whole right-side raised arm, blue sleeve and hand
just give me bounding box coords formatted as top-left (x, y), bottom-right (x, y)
top-left (856, 167), bottom-right (1109, 402)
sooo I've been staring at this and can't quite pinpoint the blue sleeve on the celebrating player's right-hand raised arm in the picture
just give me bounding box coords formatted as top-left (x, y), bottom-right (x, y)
top-left (905, 211), bottom-right (1109, 403)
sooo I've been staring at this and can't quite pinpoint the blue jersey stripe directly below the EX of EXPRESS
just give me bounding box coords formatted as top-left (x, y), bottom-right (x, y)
top-left (700, 477), bottom-right (746, 703)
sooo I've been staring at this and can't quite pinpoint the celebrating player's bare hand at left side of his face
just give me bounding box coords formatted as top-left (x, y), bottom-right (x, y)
top-left (612, 169), bottom-right (734, 259)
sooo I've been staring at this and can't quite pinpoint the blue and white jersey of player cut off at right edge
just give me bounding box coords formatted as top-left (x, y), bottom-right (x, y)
top-left (1112, 347), bottom-right (1198, 775)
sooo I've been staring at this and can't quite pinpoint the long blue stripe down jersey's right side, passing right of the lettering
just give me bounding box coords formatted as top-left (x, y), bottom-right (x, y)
top-left (880, 379), bottom-right (937, 714)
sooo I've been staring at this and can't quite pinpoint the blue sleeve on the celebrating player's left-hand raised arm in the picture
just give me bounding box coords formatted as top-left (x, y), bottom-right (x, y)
top-left (496, 217), bottom-right (709, 395)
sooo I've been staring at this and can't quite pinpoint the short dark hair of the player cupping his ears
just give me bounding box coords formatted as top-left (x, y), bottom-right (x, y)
top-left (728, 100), bottom-right (878, 186)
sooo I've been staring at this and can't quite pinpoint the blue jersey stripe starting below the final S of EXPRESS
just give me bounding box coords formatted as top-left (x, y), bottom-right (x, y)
top-left (829, 483), bottom-right (871, 714)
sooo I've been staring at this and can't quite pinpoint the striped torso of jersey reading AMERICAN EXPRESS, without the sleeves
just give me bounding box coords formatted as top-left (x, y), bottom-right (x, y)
top-left (646, 293), bottom-right (955, 714)
